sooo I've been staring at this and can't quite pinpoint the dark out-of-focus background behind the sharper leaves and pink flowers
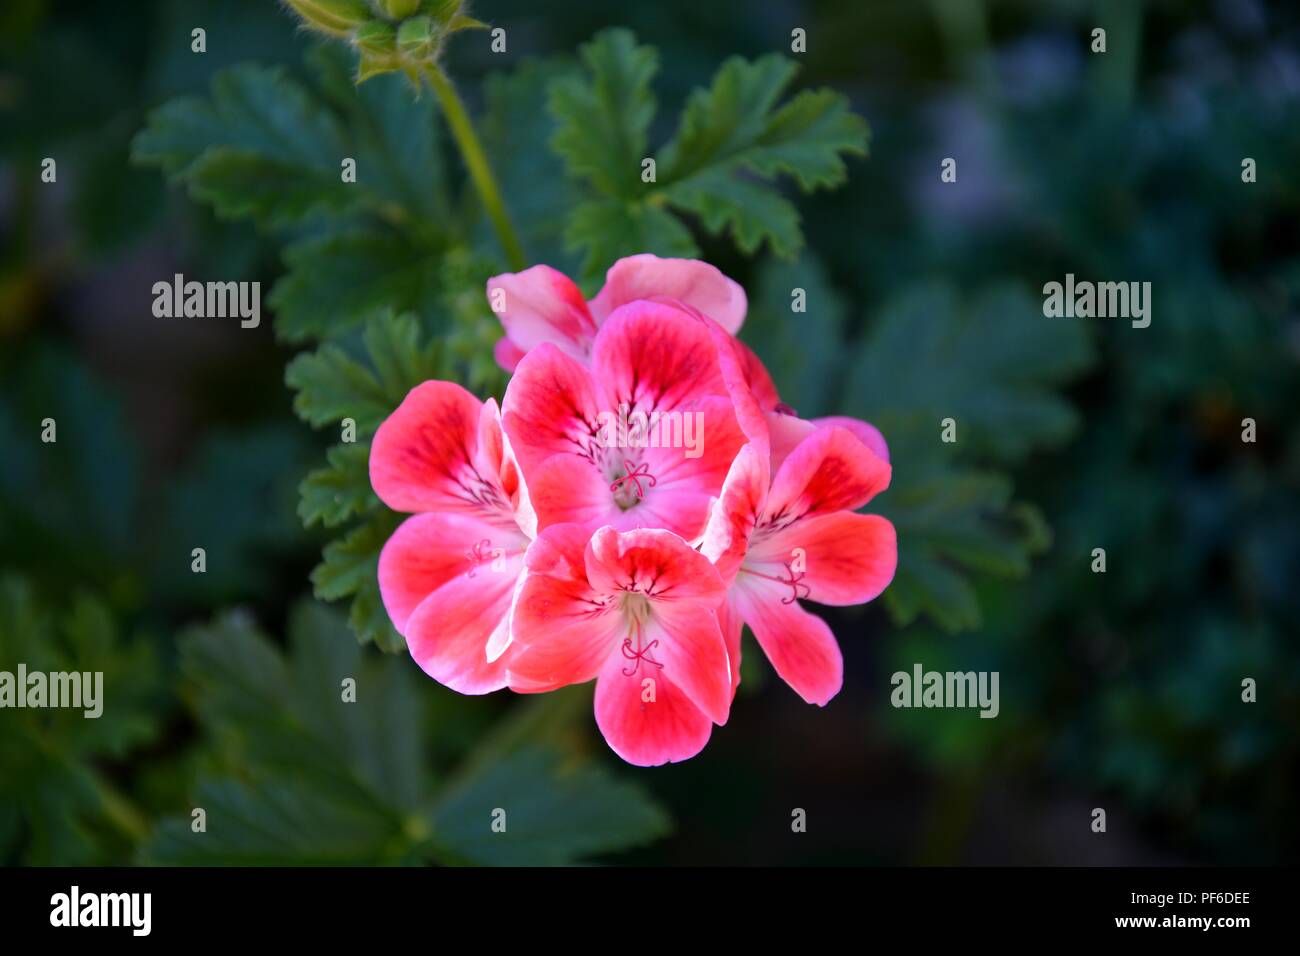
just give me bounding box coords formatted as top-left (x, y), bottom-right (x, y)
top-left (0, 0), bottom-right (1300, 864)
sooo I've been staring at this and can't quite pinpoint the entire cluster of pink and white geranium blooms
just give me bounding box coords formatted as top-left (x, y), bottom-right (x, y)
top-left (371, 255), bottom-right (897, 766)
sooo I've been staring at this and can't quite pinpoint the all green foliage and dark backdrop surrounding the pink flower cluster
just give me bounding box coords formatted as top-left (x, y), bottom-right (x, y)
top-left (0, 0), bottom-right (1300, 864)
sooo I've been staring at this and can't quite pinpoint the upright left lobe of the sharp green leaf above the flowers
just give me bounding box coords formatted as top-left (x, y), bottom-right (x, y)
top-left (550, 30), bottom-right (659, 198)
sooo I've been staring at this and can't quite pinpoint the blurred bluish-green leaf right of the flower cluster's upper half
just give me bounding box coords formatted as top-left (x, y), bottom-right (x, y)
top-left (848, 285), bottom-right (1093, 462)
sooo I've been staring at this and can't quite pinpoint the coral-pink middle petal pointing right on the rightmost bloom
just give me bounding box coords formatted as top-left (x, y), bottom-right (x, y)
top-left (745, 511), bottom-right (898, 605)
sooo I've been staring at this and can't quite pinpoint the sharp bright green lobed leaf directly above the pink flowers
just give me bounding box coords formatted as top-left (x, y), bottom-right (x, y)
top-left (550, 30), bottom-right (867, 280)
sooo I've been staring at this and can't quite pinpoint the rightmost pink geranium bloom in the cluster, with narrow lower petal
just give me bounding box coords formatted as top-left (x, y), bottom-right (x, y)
top-left (701, 426), bottom-right (898, 705)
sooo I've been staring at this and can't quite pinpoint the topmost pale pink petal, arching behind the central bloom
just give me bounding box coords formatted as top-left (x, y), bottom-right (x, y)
top-left (592, 254), bottom-right (746, 336)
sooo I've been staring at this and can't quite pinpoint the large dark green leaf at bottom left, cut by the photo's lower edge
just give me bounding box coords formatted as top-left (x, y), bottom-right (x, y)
top-left (142, 604), bottom-right (667, 865)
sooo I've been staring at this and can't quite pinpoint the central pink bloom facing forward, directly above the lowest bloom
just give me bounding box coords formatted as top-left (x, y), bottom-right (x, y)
top-left (502, 300), bottom-right (745, 540)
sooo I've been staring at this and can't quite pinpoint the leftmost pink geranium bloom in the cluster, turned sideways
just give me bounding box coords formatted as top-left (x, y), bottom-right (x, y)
top-left (371, 381), bottom-right (537, 693)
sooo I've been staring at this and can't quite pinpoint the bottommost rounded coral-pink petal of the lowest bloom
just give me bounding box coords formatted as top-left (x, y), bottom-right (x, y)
top-left (595, 654), bottom-right (714, 767)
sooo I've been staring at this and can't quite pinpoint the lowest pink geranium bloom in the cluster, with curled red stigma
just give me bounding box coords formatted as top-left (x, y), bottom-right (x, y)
top-left (510, 524), bottom-right (732, 766)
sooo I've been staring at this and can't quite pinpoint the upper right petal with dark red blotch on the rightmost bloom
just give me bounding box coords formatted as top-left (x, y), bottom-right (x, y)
top-left (759, 425), bottom-right (889, 525)
